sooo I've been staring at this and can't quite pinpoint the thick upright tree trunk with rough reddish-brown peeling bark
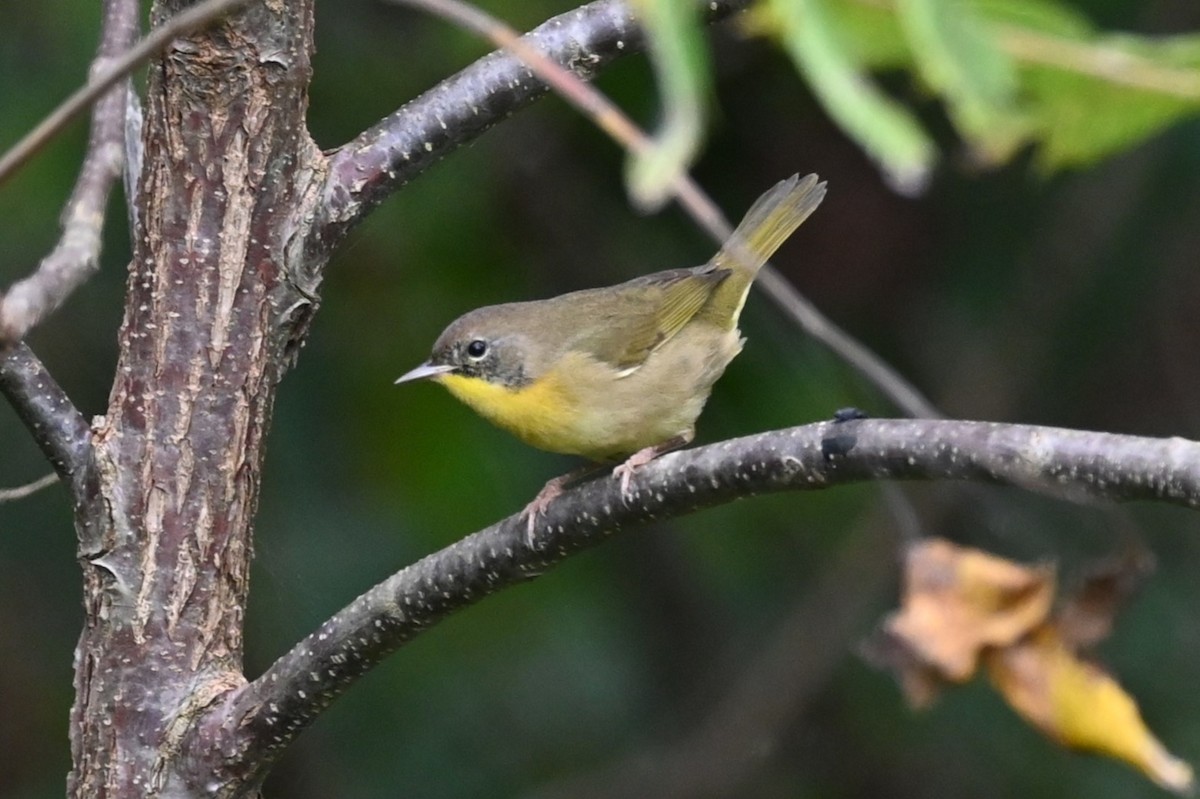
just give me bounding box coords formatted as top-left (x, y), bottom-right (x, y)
top-left (70, 2), bottom-right (323, 798)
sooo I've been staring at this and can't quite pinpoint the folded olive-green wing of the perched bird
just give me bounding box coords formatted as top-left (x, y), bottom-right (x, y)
top-left (574, 266), bottom-right (730, 371)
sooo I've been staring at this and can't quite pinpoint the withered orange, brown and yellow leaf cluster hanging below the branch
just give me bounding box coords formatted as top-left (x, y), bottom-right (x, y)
top-left (868, 539), bottom-right (1193, 793)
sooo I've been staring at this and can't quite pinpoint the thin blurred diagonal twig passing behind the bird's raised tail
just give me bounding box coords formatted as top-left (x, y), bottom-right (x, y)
top-left (391, 0), bottom-right (941, 419)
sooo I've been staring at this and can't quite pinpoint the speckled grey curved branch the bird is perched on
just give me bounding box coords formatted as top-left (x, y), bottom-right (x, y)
top-left (191, 419), bottom-right (1200, 782)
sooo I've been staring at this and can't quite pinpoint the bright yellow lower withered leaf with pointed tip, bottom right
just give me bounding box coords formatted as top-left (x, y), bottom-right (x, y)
top-left (985, 624), bottom-right (1193, 793)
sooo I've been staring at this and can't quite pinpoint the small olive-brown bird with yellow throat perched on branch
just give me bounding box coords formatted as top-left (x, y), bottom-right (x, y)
top-left (396, 175), bottom-right (826, 537)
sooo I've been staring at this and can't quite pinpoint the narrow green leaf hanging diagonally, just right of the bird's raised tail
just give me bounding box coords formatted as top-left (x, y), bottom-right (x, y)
top-left (772, 0), bottom-right (936, 194)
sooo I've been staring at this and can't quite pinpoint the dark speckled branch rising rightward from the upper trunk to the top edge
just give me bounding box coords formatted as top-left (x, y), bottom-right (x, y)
top-left (305, 0), bottom-right (749, 264)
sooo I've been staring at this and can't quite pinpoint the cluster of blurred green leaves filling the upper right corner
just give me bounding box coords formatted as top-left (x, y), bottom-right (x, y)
top-left (752, 0), bottom-right (1200, 179)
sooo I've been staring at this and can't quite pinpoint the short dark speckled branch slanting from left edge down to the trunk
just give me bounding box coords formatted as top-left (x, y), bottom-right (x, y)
top-left (0, 344), bottom-right (91, 482)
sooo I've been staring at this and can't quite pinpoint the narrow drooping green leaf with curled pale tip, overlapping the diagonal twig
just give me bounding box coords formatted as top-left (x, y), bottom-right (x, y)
top-left (625, 0), bottom-right (710, 210)
